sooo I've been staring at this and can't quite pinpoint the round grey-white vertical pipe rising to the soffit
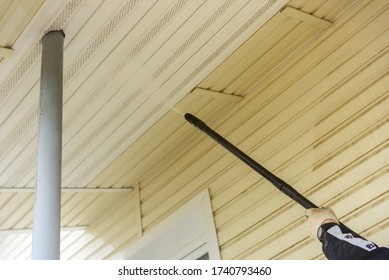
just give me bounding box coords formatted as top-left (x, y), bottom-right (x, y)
top-left (32, 30), bottom-right (65, 260)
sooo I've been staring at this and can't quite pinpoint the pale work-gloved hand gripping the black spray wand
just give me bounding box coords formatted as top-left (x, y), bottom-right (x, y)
top-left (305, 208), bottom-right (339, 239)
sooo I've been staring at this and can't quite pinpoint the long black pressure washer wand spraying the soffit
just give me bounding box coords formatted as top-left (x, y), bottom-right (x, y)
top-left (185, 113), bottom-right (359, 236)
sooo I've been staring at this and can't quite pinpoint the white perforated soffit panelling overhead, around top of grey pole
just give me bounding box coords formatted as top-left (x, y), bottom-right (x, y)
top-left (0, 0), bottom-right (287, 188)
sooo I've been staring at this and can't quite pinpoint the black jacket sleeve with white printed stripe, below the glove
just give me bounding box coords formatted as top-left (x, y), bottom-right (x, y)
top-left (320, 223), bottom-right (389, 260)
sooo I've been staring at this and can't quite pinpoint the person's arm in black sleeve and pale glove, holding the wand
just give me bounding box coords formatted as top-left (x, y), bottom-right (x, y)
top-left (306, 208), bottom-right (389, 260)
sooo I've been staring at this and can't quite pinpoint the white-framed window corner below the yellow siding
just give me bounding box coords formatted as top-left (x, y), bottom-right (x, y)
top-left (123, 189), bottom-right (221, 260)
